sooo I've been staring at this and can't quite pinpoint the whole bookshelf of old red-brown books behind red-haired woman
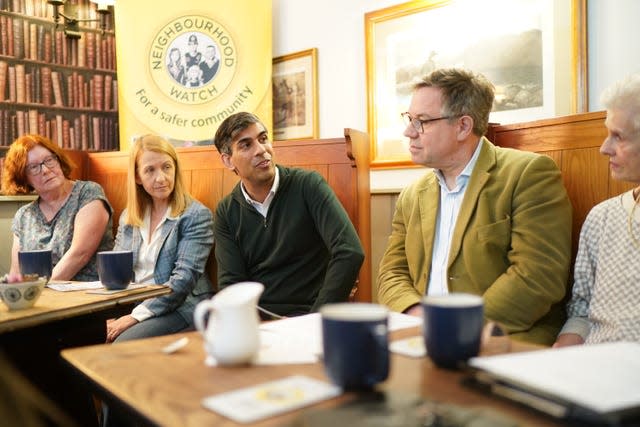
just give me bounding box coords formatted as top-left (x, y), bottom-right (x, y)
top-left (0, 0), bottom-right (120, 157)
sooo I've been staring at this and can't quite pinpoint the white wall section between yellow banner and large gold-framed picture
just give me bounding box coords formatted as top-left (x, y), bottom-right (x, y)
top-left (273, 0), bottom-right (398, 138)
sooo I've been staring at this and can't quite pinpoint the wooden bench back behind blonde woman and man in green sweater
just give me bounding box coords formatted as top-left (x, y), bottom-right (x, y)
top-left (70, 129), bottom-right (371, 301)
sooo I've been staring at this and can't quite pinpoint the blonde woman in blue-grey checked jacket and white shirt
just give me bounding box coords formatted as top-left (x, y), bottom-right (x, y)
top-left (107, 135), bottom-right (213, 342)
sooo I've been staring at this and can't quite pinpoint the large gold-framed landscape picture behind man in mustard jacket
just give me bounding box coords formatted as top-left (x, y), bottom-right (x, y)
top-left (365, 0), bottom-right (588, 168)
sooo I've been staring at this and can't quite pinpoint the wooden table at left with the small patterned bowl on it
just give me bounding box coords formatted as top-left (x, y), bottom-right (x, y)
top-left (0, 285), bottom-right (171, 426)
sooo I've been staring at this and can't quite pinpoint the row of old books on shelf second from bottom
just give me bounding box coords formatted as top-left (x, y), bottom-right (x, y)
top-left (0, 60), bottom-right (118, 111)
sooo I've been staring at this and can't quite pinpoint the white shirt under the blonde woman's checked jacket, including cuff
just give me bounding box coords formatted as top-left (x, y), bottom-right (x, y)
top-left (131, 206), bottom-right (173, 322)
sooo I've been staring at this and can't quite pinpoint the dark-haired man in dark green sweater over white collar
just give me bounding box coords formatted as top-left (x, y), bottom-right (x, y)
top-left (215, 112), bottom-right (364, 316)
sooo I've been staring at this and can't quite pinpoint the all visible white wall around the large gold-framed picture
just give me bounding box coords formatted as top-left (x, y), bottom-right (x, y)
top-left (273, 0), bottom-right (640, 191)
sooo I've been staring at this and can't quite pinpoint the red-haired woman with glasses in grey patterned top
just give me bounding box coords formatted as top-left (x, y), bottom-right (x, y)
top-left (2, 135), bottom-right (113, 281)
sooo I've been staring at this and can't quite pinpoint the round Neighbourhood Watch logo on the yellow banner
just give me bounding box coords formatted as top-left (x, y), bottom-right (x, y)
top-left (149, 15), bottom-right (237, 105)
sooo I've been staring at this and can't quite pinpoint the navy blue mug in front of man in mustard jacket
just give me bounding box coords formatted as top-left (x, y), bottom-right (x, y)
top-left (422, 293), bottom-right (484, 369)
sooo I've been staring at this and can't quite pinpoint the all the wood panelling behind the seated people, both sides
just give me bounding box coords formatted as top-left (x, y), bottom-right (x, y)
top-left (66, 111), bottom-right (633, 301)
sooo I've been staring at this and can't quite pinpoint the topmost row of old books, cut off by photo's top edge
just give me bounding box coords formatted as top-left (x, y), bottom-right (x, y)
top-left (0, 0), bottom-right (113, 30)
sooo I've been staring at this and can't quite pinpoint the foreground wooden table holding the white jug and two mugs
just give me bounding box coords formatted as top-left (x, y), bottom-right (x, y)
top-left (62, 328), bottom-right (560, 427)
